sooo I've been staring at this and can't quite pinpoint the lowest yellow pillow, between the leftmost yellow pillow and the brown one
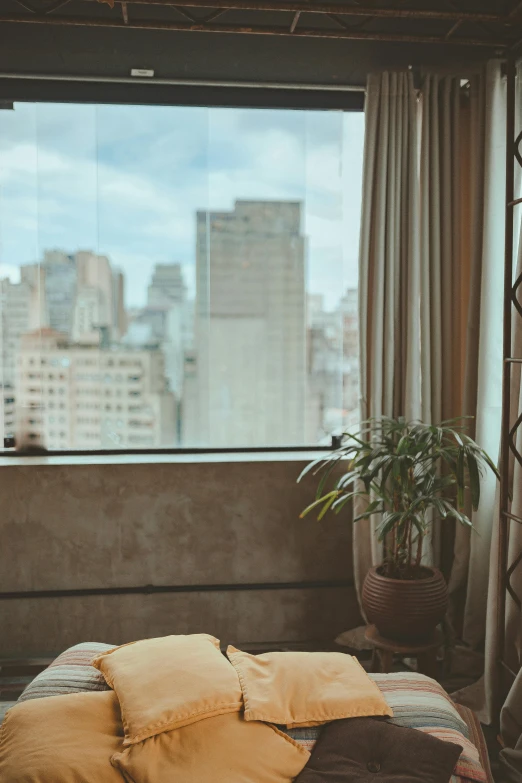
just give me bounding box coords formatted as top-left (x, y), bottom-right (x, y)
top-left (112, 712), bottom-right (310, 783)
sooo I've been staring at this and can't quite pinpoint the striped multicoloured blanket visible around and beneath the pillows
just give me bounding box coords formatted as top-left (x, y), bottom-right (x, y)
top-left (12, 642), bottom-right (493, 783)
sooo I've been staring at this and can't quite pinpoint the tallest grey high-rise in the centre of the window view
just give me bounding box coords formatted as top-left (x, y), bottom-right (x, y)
top-left (182, 201), bottom-right (306, 446)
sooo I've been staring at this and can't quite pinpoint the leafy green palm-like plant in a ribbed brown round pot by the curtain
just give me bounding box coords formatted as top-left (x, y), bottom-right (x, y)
top-left (298, 417), bottom-right (499, 642)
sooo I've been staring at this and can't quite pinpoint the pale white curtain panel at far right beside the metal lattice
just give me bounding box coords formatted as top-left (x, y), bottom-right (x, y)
top-left (457, 61), bottom-right (506, 649)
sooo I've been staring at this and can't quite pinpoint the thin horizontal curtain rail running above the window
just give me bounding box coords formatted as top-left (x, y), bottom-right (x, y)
top-left (0, 72), bottom-right (366, 92)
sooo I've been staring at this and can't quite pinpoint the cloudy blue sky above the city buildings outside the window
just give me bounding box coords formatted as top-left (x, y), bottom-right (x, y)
top-left (0, 103), bottom-right (364, 309)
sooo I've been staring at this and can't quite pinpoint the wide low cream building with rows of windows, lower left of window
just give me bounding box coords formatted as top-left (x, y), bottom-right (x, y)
top-left (16, 329), bottom-right (177, 450)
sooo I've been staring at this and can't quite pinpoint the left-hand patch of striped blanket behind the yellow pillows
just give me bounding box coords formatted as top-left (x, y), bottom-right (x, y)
top-left (18, 642), bottom-right (114, 701)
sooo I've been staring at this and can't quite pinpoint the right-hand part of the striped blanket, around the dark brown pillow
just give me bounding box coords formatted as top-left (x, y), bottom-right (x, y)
top-left (288, 672), bottom-right (486, 783)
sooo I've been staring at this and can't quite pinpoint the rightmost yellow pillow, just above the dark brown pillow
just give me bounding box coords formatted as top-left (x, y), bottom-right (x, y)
top-left (227, 647), bottom-right (393, 728)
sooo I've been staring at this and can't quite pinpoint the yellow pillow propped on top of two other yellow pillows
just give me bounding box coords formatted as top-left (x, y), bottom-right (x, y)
top-left (93, 634), bottom-right (243, 745)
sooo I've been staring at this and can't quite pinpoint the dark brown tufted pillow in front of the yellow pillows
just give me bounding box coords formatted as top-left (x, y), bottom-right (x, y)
top-left (295, 718), bottom-right (462, 783)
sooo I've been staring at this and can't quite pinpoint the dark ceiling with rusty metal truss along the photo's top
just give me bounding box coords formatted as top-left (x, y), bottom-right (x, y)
top-left (0, 0), bottom-right (522, 55)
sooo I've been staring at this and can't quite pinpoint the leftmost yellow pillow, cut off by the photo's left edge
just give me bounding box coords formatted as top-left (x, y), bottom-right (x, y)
top-left (0, 691), bottom-right (123, 783)
